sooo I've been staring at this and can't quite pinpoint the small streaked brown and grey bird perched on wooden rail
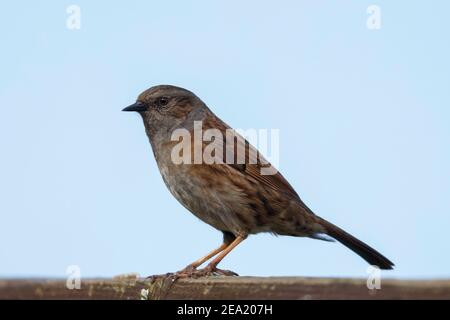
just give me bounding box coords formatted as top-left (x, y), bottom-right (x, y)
top-left (123, 85), bottom-right (394, 276)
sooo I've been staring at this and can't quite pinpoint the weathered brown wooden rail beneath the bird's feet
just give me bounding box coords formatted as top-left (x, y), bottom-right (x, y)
top-left (0, 277), bottom-right (450, 300)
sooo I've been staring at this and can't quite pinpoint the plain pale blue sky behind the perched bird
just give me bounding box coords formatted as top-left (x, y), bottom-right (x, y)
top-left (0, 0), bottom-right (450, 278)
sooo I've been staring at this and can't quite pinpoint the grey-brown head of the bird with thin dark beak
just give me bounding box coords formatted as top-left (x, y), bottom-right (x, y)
top-left (122, 85), bottom-right (211, 139)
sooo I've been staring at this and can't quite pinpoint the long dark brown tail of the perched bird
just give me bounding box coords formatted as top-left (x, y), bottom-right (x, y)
top-left (320, 218), bottom-right (394, 270)
